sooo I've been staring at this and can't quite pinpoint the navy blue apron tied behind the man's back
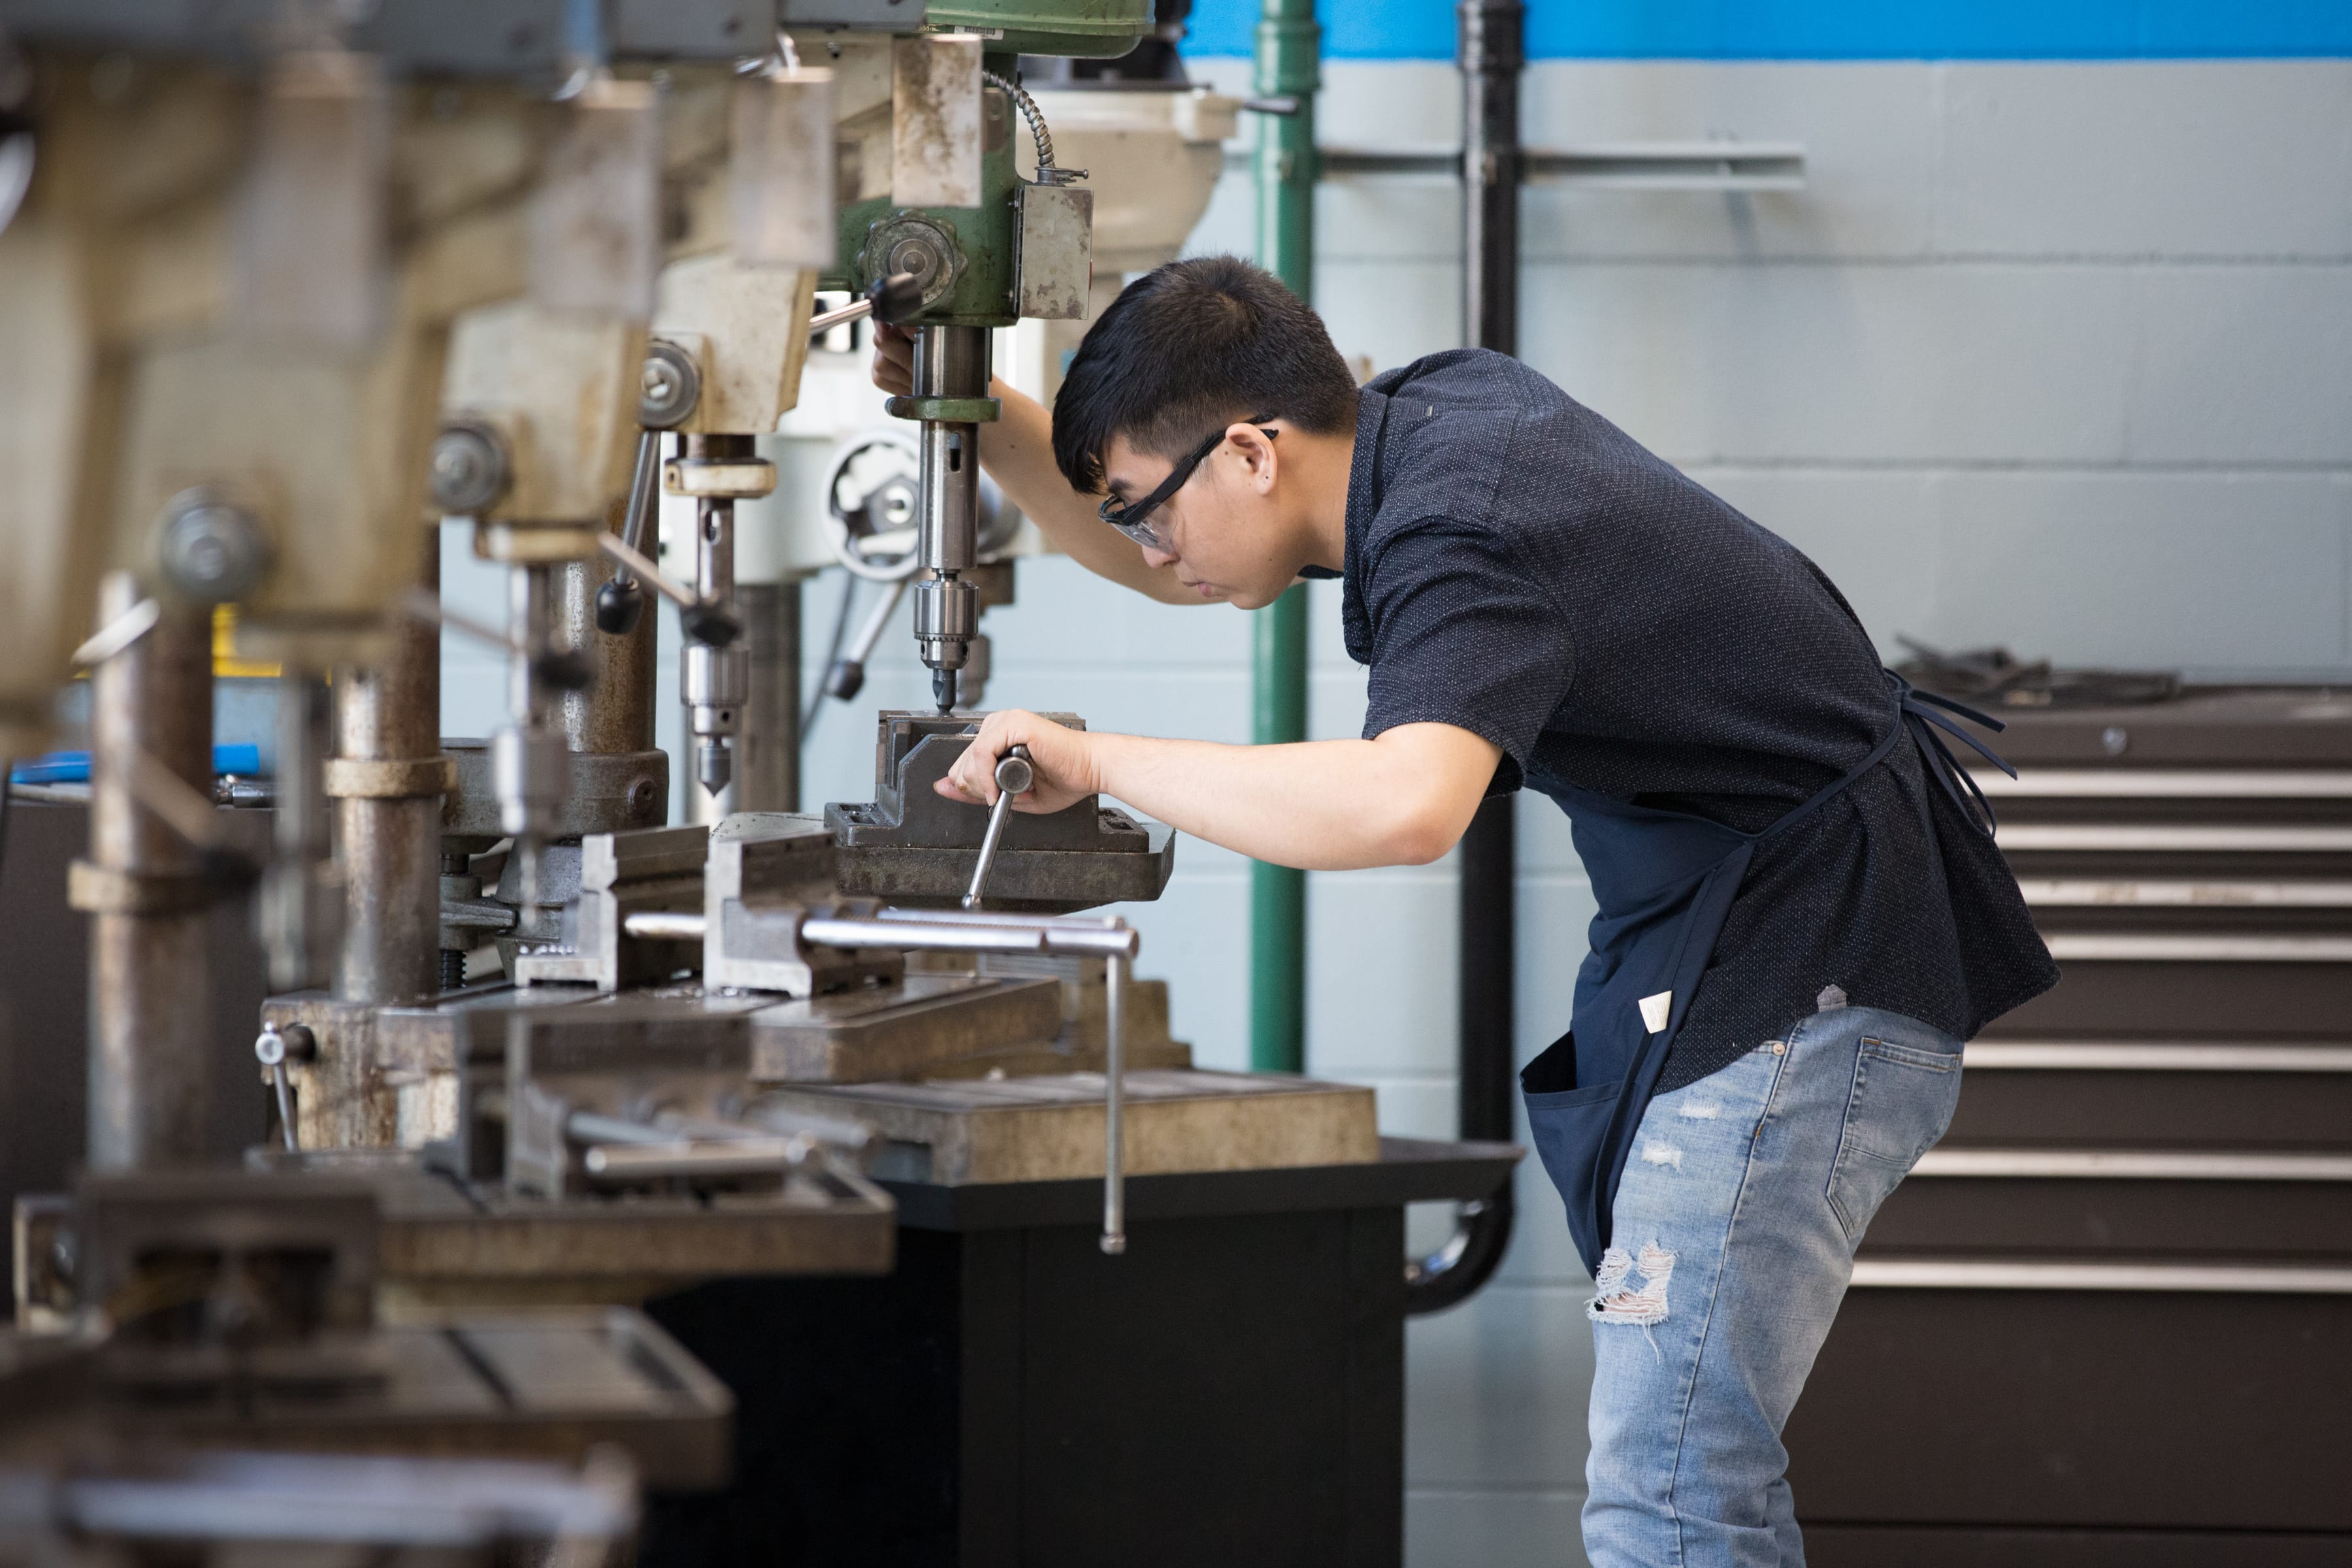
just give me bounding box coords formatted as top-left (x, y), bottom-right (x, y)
top-left (1520, 670), bottom-right (2016, 1274)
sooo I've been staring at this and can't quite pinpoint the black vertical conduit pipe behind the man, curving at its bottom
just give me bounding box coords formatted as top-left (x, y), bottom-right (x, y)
top-left (1404, 0), bottom-right (1526, 1314)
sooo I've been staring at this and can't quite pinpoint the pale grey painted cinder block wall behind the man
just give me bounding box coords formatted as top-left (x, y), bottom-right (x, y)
top-left (447, 15), bottom-right (2352, 1568)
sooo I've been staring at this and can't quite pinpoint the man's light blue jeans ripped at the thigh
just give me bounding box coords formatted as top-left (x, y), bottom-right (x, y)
top-left (1583, 1006), bottom-right (1961, 1568)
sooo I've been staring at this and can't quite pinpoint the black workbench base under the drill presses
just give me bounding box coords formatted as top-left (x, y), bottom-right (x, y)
top-left (640, 1138), bottom-right (1520, 1568)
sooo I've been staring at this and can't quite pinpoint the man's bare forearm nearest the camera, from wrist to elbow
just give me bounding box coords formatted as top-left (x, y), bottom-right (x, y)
top-left (1089, 734), bottom-right (1477, 872)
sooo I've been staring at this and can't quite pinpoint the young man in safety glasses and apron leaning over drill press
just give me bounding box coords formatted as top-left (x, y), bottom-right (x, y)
top-left (875, 259), bottom-right (2055, 1568)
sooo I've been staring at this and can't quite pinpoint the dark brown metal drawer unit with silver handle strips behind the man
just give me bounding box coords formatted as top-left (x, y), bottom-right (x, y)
top-left (1788, 689), bottom-right (2352, 1568)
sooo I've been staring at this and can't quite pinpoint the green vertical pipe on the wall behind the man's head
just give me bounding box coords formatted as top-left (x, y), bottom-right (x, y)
top-left (1249, 0), bottom-right (1322, 1072)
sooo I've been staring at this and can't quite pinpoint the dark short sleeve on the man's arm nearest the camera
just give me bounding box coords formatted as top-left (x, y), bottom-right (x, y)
top-left (1364, 519), bottom-right (1576, 794)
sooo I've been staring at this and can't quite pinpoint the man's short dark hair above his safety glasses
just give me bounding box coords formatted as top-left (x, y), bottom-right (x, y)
top-left (1054, 256), bottom-right (1355, 494)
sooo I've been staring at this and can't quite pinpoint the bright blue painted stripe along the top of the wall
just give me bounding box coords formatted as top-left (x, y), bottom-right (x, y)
top-left (1185, 0), bottom-right (2352, 59)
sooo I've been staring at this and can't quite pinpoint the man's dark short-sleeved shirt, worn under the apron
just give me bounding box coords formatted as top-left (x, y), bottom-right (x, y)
top-left (1343, 348), bottom-right (2058, 1093)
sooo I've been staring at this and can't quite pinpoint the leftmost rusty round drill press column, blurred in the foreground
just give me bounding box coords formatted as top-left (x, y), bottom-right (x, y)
top-left (73, 574), bottom-right (212, 1171)
